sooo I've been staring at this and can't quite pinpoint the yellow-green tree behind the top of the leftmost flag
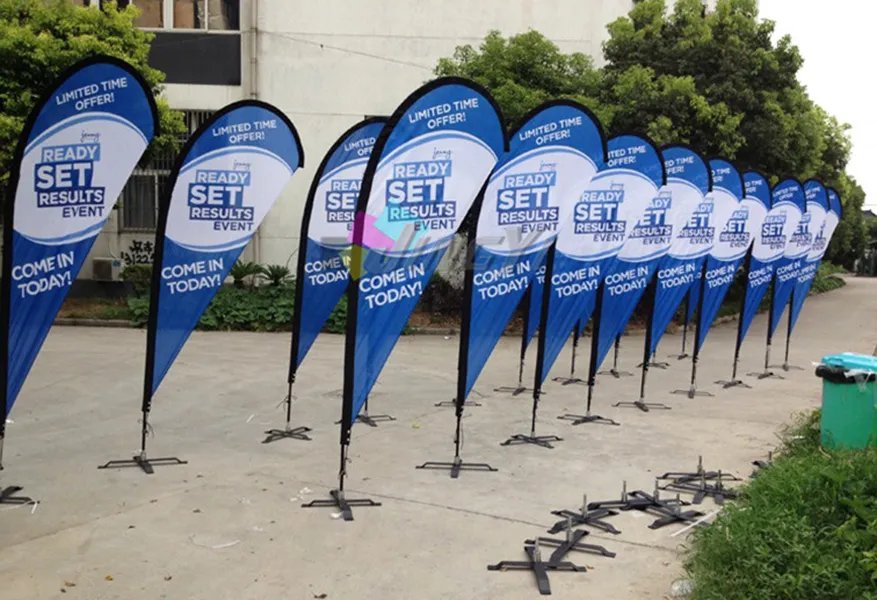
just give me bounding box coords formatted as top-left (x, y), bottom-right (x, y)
top-left (0, 0), bottom-right (185, 188)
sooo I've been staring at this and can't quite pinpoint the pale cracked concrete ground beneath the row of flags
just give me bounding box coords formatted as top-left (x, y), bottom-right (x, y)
top-left (0, 278), bottom-right (877, 600)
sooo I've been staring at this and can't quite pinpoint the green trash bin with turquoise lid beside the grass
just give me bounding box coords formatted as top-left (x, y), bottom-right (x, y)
top-left (816, 352), bottom-right (877, 449)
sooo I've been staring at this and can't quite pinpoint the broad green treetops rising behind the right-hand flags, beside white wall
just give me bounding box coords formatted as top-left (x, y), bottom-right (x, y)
top-left (436, 0), bottom-right (867, 267)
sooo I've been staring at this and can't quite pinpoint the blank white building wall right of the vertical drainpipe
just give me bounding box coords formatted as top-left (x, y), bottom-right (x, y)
top-left (250, 0), bottom-right (633, 264)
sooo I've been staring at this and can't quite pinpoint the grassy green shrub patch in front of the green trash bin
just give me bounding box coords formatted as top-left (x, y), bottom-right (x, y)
top-left (686, 413), bottom-right (877, 600)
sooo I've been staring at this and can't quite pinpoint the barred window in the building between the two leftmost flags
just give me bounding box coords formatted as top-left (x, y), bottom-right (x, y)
top-left (120, 110), bottom-right (213, 232)
